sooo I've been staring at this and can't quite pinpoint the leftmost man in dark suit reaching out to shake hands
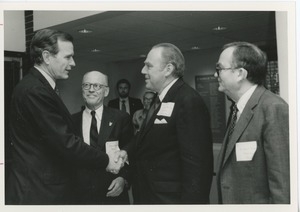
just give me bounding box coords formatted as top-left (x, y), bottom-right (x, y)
top-left (5, 29), bottom-right (121, 205)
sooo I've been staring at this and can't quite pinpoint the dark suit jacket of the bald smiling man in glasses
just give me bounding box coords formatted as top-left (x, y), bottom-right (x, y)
top-left (72, 106), bottom-right (133, 204)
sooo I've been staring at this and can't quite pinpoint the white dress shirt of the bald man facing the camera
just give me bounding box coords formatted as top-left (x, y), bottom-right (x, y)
top-left (82, 105), bottom-right (103, 145)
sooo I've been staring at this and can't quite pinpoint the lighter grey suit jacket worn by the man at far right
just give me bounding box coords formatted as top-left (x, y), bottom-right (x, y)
top-left (217, 86), bottom-right (290, 204)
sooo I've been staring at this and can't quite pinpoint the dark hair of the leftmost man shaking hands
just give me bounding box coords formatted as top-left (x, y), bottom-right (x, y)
top-left (30, 29), bottom-right (73, 65)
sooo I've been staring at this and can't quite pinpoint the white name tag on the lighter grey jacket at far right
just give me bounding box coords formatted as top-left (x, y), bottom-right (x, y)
top-left (235, 141), bottom-right (257, 161)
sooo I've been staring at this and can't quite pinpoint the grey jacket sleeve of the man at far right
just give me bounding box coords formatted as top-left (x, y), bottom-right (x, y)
top-left (263, 103), bottom-right (290, 204)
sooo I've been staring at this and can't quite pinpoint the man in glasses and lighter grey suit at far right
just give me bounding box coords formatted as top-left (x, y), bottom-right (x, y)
top-left (215, 42), bottom-right (290, 204)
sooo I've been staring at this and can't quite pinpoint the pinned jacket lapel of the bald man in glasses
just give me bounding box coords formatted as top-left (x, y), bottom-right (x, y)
top-left (98, 106), bottom-right (115, 150)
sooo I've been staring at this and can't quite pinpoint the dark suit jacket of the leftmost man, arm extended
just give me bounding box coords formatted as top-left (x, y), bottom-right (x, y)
top-left (6, 68), bottom-right (108, 204)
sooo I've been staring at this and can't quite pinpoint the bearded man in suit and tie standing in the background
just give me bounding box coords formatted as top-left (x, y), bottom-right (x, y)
top-left (108, 79), bottom-right (143, 118)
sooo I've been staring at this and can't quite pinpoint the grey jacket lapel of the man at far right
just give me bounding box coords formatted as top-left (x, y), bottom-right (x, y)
top-left (221, 86), bottom-right (266, 165)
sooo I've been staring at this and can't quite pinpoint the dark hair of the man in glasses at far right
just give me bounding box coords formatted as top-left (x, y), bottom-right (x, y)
top-left (223, 42), bottom-right (267, 85)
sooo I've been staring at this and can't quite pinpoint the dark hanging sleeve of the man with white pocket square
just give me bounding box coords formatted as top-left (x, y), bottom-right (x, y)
top-left (176, 95), bottom-right (213, 204)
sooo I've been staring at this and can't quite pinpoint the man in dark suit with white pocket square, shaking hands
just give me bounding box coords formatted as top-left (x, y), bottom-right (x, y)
top-left (125, 43), bottom-right (213, 204)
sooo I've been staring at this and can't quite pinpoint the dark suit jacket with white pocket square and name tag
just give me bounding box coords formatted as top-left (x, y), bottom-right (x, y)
top-left (126, 79), bottom-right (213, 204)
